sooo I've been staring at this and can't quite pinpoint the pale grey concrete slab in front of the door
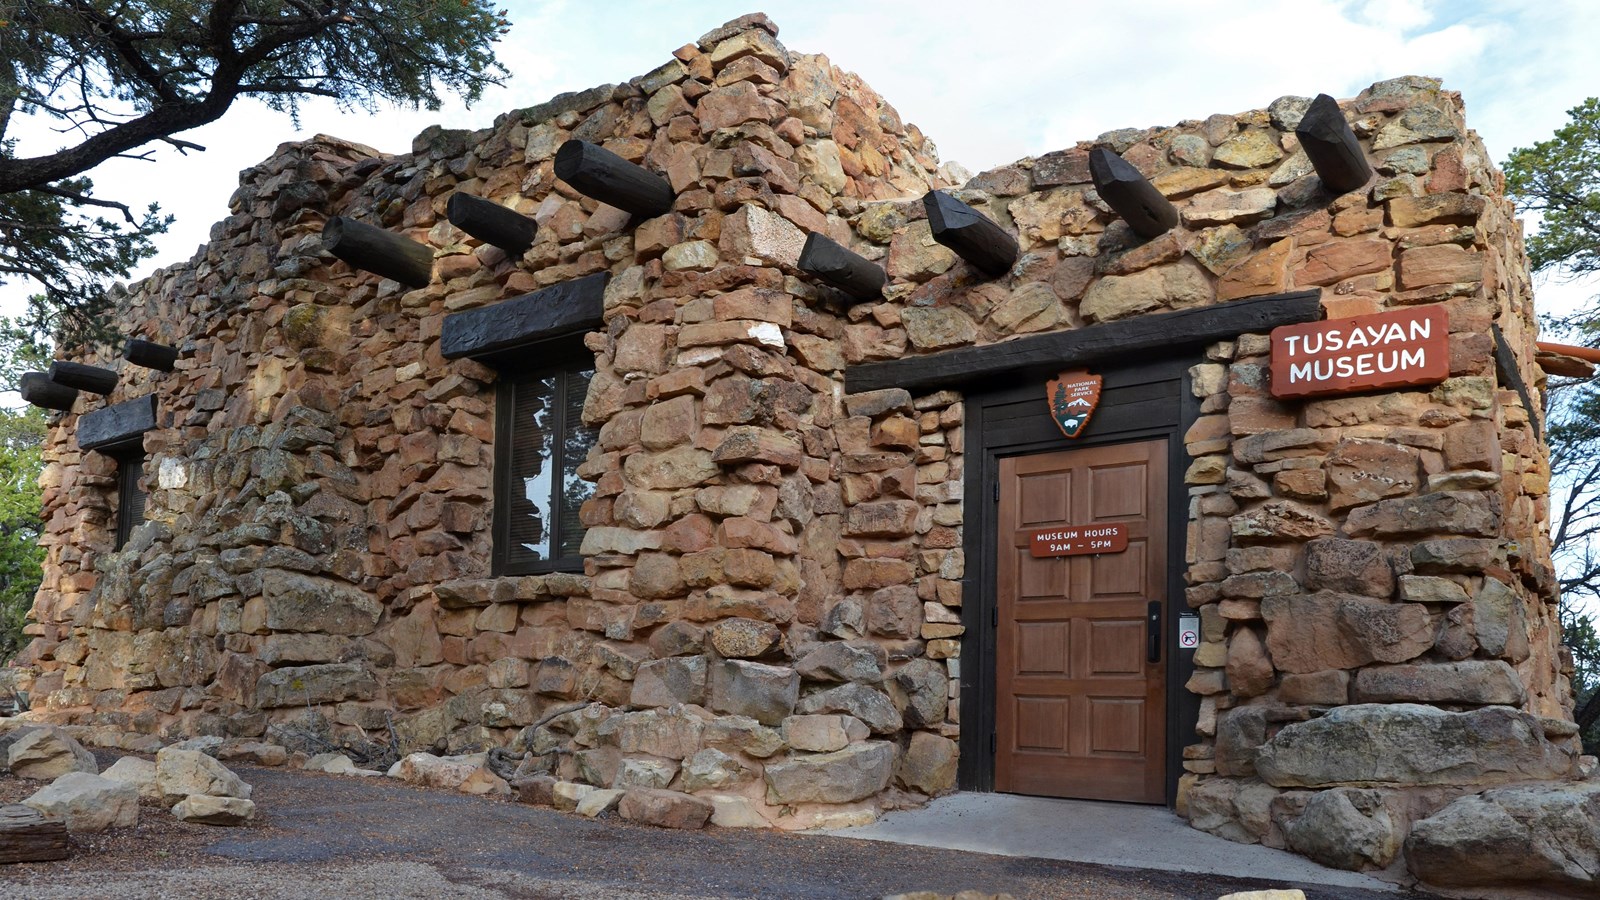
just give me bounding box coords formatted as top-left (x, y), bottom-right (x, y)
top-left (829, 793), bottom-right (1400, 892)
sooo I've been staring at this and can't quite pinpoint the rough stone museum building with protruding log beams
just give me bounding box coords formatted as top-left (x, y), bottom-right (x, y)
top-left (12, 16), bottom-right (1594, 882)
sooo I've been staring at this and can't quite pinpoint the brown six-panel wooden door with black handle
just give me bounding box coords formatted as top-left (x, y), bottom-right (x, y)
top-left (995, 440), bottom-right (1166, 802)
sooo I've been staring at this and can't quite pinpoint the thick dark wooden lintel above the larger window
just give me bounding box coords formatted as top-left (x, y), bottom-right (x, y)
top-left (438, 272), bottom-right (611, 365)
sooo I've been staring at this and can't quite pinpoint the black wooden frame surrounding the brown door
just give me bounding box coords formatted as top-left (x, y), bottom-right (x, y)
top-left (957, 352), bottom-right (1202, 806)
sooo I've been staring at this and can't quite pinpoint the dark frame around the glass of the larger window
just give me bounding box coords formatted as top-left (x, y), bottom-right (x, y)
top-left (490, 344), bottom-right (595, 577)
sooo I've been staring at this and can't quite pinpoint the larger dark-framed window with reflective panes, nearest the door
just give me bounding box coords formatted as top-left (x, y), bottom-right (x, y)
top-left (494, 359), bottom-right (598, 575)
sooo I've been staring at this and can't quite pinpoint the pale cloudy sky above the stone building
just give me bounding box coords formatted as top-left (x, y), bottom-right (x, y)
top-left (0, 0), bottom-right (1600, 307)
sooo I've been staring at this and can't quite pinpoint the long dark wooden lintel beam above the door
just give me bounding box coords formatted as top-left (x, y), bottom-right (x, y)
top-left (845, 290), bottom-right (1322, 393)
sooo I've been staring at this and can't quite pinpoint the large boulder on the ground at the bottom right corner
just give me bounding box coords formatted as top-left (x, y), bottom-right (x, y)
top-left (1405, 781), bottom-right (1600, 897)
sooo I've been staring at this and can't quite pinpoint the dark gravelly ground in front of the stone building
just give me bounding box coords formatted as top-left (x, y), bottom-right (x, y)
top-left (0, 756), bottom-right (1427, 900)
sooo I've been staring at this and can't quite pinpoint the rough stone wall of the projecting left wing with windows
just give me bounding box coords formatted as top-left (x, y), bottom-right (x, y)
top-left (18, 16), bottom-right (960, 822)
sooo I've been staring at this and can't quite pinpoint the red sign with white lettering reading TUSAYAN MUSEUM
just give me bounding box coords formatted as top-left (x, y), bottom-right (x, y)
top-left (1272, 306), bottom-right (1450, 397)
